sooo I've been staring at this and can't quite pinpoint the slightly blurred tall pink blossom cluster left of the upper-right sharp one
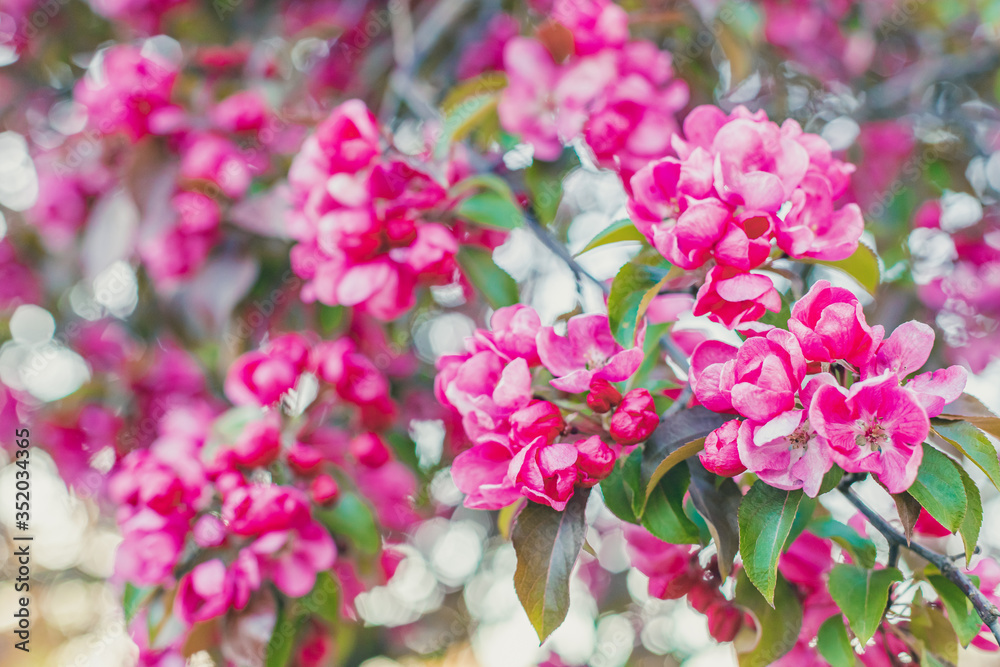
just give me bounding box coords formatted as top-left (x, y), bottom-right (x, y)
top-left (288, 100), bottom-right (458, 320)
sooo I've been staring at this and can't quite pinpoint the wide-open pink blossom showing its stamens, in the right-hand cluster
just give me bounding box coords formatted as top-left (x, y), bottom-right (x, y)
top-left (809, 373), bottom-right (930, 493)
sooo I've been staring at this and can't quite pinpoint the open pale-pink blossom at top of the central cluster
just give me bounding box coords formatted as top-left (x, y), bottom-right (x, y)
top-left (537, 314), bottom-right (642, 393)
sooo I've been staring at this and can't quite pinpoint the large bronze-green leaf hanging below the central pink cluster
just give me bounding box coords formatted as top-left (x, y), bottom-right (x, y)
top-left (513, 489), bottom-right (589, 642)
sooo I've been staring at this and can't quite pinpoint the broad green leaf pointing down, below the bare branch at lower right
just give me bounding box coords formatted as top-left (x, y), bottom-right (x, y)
top-left (829, 563), bottom-right (903, 646)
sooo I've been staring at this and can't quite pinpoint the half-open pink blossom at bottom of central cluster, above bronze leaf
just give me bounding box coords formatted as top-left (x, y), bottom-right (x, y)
top-left (507, 437), bottom-right (579, 511)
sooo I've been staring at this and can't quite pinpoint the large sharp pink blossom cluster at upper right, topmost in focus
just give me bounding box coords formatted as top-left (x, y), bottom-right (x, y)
top-left (629, 106), bottom-right (864, 327)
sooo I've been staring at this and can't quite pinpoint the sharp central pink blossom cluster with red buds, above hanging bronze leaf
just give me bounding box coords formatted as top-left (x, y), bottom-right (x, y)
top-left (435, 305), bottom-right (659, 510)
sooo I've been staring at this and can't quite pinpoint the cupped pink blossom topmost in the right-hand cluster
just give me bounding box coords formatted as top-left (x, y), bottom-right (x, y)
top-left (788, 280), bottom-right (884, 369)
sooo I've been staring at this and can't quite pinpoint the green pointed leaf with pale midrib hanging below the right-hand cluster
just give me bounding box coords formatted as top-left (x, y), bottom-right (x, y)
top-left (739, 480), bottom-right (802, 604)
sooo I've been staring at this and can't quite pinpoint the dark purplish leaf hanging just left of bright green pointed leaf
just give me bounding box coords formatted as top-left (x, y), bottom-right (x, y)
top-left (687, 458), bottom-right (743, 579)
